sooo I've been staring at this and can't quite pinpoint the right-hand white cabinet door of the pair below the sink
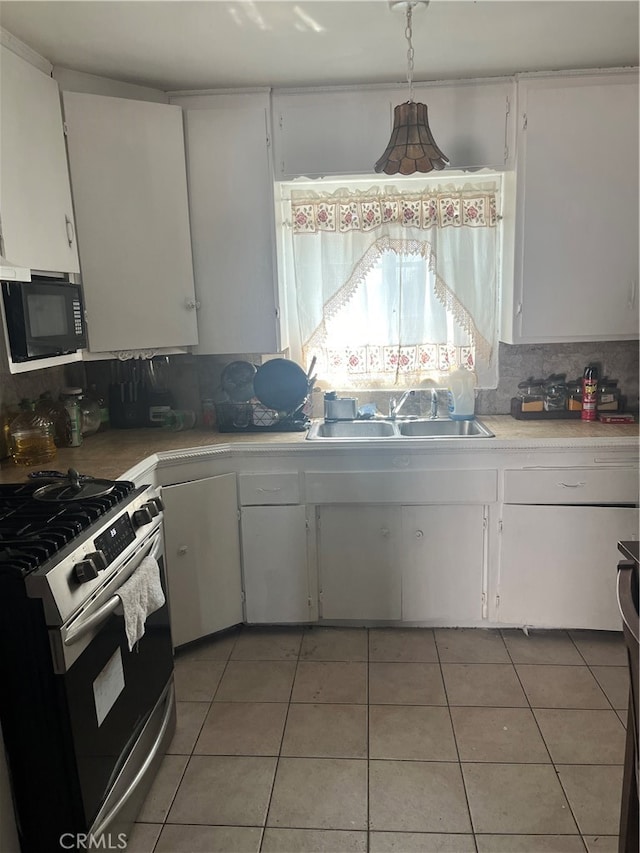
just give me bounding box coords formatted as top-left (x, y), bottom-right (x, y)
top-left (402, 506), bottom-right (484, 625)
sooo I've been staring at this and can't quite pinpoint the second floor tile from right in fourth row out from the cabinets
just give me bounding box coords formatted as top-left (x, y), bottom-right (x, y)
top-left (462, 764), bottom-right (578, 835)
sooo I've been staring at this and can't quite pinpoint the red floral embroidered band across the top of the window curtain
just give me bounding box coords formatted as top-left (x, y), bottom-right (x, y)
top-left (291, 189), bottom-right (498, 234)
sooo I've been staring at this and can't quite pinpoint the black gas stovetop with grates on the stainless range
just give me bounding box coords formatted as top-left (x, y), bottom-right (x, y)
top-left (0, 480), bottom-right (135, 576)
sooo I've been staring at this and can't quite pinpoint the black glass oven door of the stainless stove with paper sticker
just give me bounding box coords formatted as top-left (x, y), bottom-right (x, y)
top-left (58, 527), bottom-right (173, 826)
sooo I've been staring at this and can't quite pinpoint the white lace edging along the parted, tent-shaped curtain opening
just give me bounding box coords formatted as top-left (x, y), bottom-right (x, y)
top-left (303, 236), bottom-right (491, 361)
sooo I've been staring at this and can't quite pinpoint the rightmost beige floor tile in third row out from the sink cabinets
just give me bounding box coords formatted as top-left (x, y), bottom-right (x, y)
top-left (535, 708), bottom-right (625, 764)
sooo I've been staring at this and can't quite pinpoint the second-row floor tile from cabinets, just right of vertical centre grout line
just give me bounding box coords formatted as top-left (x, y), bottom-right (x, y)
top-left (369, 662), bottom-right (447, 705)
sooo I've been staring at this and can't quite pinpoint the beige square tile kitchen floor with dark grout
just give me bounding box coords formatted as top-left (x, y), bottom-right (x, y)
top-left (128, 627), bottom-right (628, 853)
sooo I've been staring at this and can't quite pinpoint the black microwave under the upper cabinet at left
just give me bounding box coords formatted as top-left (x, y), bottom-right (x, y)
top-left (2, 277), bottom-right (87, 362)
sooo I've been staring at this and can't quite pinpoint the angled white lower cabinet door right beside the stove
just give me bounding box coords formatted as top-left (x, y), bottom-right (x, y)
top-left (162, 474), bottom-right (242, 646)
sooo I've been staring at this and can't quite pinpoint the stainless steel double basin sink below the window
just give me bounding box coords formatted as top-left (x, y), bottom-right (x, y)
top-left (307, 418), bottom-right (493, 441)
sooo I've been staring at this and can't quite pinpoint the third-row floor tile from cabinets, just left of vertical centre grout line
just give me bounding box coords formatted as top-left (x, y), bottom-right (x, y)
top-left (282, 703), bottom-right (367, 758)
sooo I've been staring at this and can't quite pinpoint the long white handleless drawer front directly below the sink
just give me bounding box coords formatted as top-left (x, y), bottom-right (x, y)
top-left (305, 470), bottom-right (498, 504)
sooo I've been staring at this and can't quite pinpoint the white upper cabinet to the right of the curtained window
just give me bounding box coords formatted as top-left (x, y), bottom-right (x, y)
top-left (501, 72), bottom-right (638, 343)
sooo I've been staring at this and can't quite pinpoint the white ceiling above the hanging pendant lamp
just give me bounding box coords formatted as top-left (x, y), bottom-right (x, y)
top-left (0, 0), bottom-right (639, 91)
